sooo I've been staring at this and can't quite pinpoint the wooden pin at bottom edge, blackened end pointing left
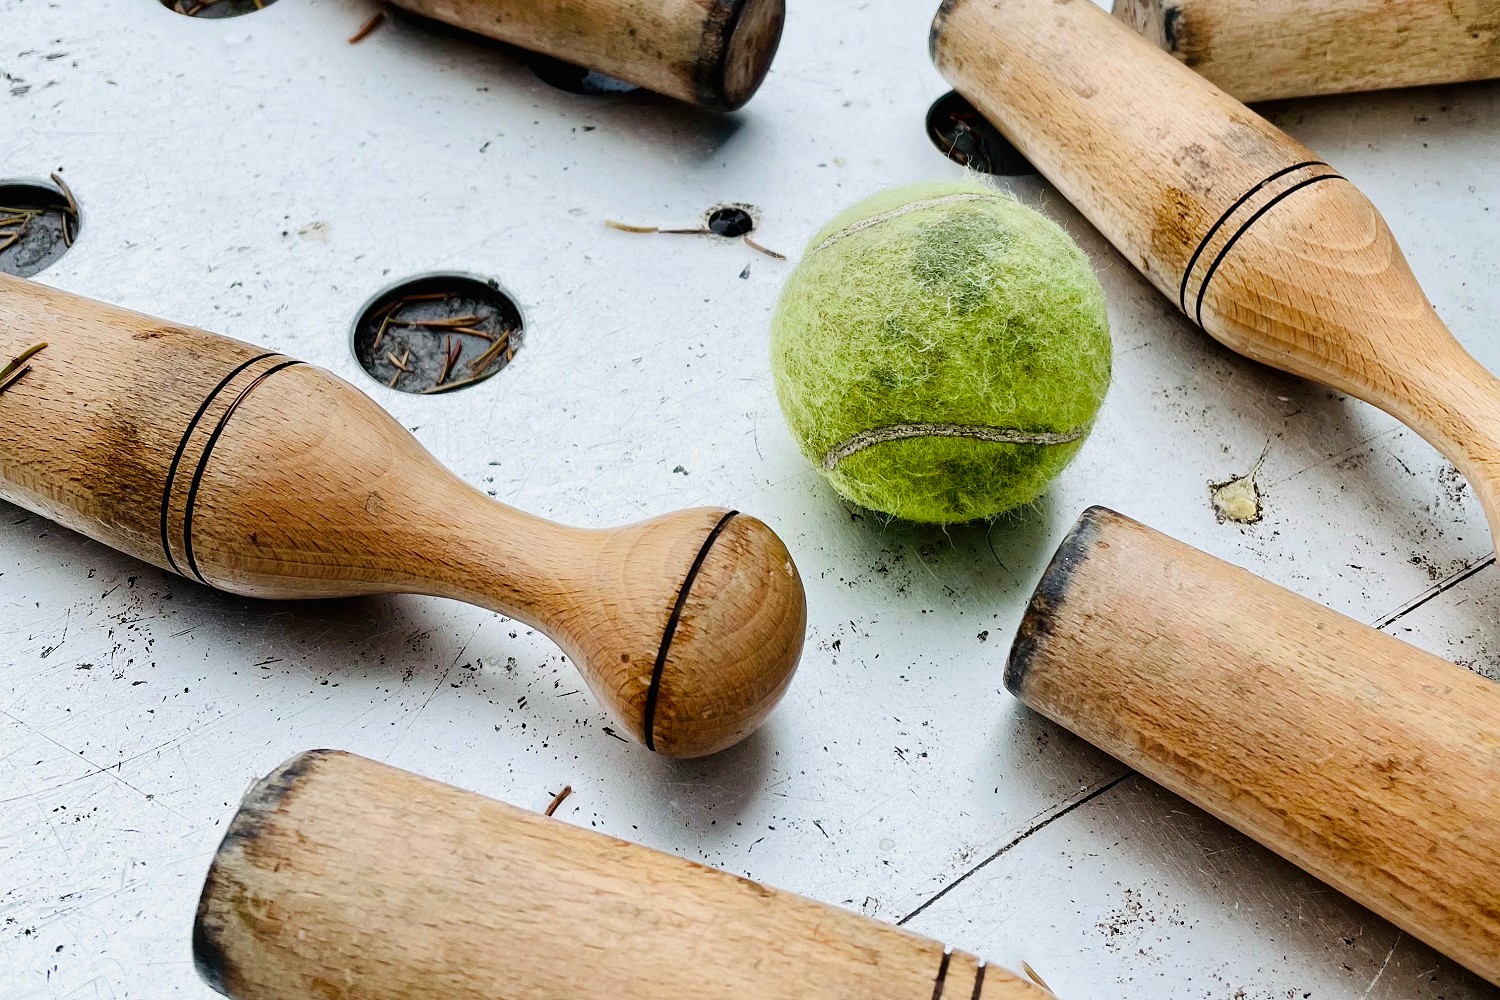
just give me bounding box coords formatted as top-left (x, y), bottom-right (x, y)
top-left (194, 751), bottom-right (1052, 1000)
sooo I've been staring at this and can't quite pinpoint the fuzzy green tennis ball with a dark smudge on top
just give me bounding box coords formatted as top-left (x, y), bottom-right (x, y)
top-left (771, 183), bottom-right (1110, 525)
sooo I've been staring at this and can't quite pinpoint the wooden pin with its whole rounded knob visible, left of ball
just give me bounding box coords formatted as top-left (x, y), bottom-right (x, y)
top-left (0, 274), bottom-right (806, 757)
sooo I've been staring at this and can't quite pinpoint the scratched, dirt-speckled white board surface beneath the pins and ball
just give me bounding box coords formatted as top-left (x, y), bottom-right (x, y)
top-left (0, 0), bottom-right (1500, 1000)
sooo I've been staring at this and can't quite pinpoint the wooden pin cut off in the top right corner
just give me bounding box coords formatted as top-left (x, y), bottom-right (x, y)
top-left (1115, 0), bottom-right (1500, 100)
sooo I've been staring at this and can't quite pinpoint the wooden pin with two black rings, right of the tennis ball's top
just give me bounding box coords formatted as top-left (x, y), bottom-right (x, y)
top-left (932, 0), bottom-right (1500, 551)
